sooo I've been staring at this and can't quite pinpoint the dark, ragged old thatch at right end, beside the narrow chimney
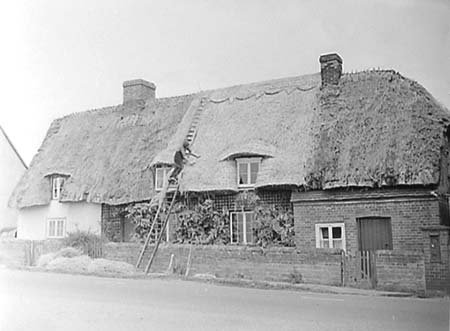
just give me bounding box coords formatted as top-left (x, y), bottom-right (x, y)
top-left (308, 71), bottom-right (450, 189)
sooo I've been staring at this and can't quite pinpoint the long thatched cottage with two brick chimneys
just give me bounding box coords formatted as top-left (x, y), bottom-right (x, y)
top-left (11, 54), bottom-right (450, 292)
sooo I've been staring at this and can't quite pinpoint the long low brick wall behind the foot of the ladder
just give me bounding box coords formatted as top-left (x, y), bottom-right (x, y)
top-left (103, 243), bottom-right (341, 285)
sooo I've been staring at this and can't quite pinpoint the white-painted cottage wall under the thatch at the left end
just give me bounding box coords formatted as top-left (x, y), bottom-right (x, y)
top-left (17, 200), bottom-right (102, 240)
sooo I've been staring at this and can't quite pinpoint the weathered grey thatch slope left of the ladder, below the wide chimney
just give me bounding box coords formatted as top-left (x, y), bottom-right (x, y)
top-left (11, 95), bottom-right (193, 208)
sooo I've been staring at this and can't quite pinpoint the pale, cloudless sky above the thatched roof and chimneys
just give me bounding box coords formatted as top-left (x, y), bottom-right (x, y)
top-left (0, 0), bottom-right (450, 164)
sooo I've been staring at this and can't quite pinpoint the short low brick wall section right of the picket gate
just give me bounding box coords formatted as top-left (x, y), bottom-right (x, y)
top-left (376, 250), bottom-right (426, 293)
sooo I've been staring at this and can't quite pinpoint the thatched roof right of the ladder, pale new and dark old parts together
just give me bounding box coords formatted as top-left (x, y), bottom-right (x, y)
top-left (154, 71), bottom-right (450, 191)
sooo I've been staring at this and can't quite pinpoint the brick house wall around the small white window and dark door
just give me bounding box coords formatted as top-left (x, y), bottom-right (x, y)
top-left (294, 196), bottom-right (440, 254)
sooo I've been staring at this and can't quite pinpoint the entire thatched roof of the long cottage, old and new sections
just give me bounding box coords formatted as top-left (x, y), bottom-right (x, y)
top-left (12, 71), bottom-right (450, 207)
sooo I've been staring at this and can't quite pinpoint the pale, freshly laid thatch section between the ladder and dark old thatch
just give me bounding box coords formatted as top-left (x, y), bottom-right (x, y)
top-left (154, 74), bottom-right (320, 191)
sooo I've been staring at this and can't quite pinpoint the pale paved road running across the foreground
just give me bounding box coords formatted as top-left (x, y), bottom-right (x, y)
top-left (0, 269), bottom-right (449, 331)
